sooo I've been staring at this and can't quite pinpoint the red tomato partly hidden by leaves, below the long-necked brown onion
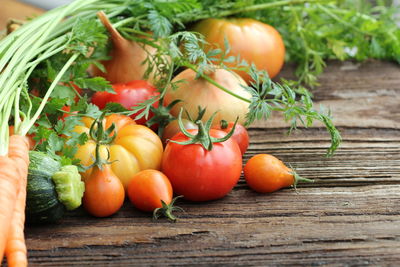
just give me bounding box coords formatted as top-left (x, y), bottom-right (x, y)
top-left (92, 80), bottom-right (159, 125)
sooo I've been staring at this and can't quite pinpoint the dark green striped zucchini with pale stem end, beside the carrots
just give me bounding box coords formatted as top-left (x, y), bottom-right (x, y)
top-left (25, 151), bottom-right (84, 223)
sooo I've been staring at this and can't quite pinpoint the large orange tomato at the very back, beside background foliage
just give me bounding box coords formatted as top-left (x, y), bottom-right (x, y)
top-left (193, 18), bottom-right (285, 82)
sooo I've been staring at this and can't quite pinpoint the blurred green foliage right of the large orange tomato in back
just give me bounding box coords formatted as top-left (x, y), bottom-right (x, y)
top-left (249, 0), bottom-right (400, 86)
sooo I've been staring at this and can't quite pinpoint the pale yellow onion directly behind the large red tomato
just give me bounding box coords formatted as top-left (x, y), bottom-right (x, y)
top-left (164, 69), bottom-right (251, 125)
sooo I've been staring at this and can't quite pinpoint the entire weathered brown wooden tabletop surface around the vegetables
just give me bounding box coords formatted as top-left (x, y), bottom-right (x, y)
top-left (21, 61), bottom-right (400, 266)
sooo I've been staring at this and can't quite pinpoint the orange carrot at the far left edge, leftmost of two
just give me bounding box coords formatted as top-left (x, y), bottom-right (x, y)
top-left (0, 156), bottom-right (19, 263)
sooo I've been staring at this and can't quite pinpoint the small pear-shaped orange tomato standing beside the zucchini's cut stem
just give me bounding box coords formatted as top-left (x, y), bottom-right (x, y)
top-left (83, 165), bottom-right (125, 217)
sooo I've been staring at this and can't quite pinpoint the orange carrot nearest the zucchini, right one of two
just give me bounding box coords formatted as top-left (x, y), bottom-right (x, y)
top-left (5, 135), bottom-right (29, 267)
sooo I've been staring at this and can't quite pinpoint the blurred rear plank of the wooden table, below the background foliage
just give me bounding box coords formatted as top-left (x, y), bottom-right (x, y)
top-left (264, 60), bottom-right (400, 129)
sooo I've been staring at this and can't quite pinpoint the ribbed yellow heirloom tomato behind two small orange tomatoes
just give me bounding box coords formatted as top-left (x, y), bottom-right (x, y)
top-left (74, 114), bottom-right (163, 189)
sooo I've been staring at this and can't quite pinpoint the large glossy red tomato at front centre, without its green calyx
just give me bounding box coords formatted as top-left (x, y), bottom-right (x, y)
top-left (161, 129), bottom-right (242, 201)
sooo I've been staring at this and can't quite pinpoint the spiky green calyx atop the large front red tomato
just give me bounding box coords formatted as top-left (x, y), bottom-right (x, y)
top-left (170, 109), bottom-right (239, 151)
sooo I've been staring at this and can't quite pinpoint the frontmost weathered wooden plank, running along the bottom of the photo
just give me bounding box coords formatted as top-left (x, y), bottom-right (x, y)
top-left (27, 185), bottom-right (400, 266)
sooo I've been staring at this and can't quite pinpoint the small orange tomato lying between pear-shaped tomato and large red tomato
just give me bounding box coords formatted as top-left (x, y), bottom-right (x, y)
top-left (128, 170), bottom-right (172, 212)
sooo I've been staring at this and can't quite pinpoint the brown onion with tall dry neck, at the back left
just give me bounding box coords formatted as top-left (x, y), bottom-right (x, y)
top-left (91, 11), bottom-right (162, 83)
